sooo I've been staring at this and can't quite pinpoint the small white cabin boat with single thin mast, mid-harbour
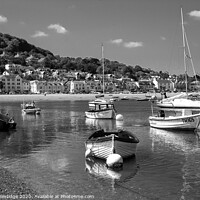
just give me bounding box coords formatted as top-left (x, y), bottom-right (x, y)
top-left (85, 44), bottom-right (117, 119)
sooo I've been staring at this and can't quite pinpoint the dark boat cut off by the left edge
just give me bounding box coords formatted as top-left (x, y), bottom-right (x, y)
top-left (0, 113), bottom-right (17, 131)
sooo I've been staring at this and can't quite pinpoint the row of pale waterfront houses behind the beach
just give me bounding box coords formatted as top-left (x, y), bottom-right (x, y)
top-left (0, 74), bottom-right (199, 94)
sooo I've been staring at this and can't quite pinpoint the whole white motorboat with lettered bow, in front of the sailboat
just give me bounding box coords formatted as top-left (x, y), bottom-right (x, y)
top-left (149, 109), bottom-right (200, 130)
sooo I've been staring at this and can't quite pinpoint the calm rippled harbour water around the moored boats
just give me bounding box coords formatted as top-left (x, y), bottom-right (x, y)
top-left (0, 100), bottom-right (200, 200)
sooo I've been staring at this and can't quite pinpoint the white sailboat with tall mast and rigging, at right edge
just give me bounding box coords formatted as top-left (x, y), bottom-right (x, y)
top-left (156, 8), bottom-right (200, 110)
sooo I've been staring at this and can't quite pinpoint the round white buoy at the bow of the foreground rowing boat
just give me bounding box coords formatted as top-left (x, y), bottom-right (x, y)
top-left (106, 153), bottom-right (123, 168)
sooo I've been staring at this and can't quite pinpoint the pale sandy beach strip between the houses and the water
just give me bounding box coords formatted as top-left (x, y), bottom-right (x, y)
top-left (0, 93), bottom-right (177, 102)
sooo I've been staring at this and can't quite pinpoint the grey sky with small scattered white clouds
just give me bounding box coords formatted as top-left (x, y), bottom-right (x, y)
top-left (0, 0), bottom-right (200, 76)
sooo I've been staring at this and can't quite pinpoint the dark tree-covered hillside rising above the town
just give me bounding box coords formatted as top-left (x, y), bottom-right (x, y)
top-left (0, 33), bottom-right (168, 80)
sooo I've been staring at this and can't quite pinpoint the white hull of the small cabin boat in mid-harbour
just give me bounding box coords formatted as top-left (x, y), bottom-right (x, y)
top-left (85, 109), bottom-right (116, 119)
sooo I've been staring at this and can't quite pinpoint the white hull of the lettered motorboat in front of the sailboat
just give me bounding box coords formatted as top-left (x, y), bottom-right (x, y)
top-left (149, 114), bottom-right (200, 130)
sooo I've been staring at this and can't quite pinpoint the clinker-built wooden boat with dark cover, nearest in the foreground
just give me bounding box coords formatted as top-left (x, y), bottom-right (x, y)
top-left (85, 129), bottom-right (139, 160)
